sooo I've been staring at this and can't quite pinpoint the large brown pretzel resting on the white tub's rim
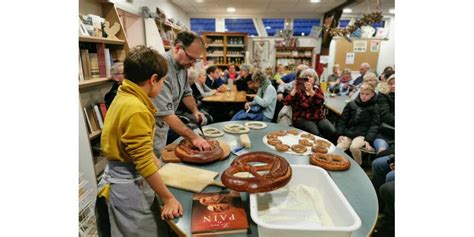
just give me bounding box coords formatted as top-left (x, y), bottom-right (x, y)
top-left (221, 151), bottom-right (292, 193)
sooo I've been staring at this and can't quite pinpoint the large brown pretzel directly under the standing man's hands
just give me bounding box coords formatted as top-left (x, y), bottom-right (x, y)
top-left (174, 139), bottom-right (224, 164)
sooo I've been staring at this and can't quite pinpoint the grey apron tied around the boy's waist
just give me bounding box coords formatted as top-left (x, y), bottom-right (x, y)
top-left (99, 160), bottom-right (160, 237)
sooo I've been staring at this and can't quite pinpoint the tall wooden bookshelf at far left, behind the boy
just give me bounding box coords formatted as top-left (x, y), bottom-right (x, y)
top-left (78, 1), bottom-right (130, 187)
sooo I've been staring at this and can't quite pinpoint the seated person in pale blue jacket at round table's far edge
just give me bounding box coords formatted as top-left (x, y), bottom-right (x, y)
top-left (231, 71), bottom-right (276, 122)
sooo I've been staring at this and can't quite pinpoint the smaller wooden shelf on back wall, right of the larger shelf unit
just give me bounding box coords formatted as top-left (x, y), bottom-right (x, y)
top-left (275, 46), bottom-right (314, 71)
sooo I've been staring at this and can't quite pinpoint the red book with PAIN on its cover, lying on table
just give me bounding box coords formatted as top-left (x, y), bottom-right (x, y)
top-left (191, 192), bottom-right (249, 236)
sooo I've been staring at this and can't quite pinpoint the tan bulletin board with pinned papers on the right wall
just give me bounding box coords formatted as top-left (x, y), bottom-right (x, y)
top-left (335, 38), bottom-right (381, 71)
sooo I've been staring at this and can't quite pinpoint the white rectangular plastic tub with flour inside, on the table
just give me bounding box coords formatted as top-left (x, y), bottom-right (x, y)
top-left (250, 165), bottom-right (361, 237)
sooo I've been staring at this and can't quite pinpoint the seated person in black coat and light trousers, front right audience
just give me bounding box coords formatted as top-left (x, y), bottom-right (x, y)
top-left (337, 83), bottom-right (380, 165)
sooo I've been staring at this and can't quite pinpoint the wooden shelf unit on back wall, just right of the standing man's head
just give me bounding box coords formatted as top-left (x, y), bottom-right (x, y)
top-left (202, 32), bottom-right (247, 67)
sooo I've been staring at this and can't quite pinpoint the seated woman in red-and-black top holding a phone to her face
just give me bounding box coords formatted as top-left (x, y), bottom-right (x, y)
top-left (283, 68), bottom-right (336, 142)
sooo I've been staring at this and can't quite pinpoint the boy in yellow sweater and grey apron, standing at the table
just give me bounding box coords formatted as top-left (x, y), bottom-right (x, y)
top-left (101, 46), bottom-right (183, 236)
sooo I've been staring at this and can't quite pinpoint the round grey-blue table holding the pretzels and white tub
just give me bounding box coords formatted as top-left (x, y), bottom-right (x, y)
top-left (161, 121), bottom-right (378, 237)
